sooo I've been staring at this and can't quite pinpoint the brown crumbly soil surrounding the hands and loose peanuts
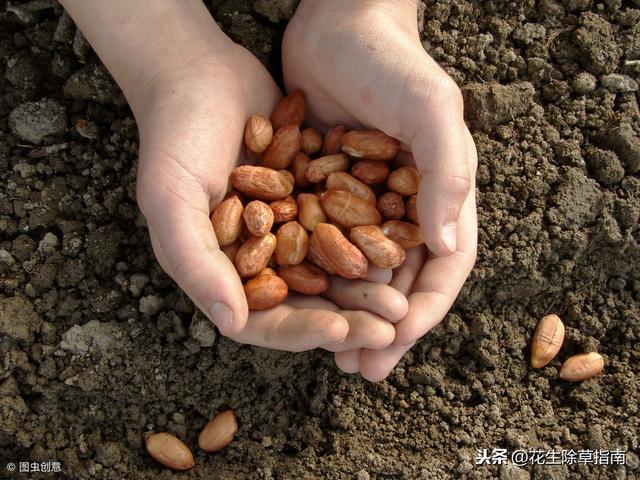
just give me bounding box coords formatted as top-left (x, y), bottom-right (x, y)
top-left (0, 0), bottom-right (640, 480)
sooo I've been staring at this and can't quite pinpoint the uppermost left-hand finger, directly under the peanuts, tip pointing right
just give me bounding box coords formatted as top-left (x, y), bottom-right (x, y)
top-left (323, 277), bottom-right (409, 322)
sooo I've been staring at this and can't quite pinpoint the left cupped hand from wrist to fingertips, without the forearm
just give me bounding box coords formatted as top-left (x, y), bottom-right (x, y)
top-left (135, 42), bottom-right (407, 351)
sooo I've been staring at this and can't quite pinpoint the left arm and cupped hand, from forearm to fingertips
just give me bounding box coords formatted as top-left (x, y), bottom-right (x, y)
top-left (64, 0), bottom-right (407, 351)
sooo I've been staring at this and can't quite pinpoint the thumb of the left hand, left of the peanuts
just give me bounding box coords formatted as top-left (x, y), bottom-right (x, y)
top-left (138, 171), bottom-right (248, 336)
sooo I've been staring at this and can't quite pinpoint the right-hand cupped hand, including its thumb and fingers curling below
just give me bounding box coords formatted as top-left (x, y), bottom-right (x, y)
top-left (283, 0), bottom-right (477, 380)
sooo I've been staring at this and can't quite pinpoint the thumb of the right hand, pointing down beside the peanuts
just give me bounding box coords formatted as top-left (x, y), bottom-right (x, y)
top-left (411, 69), bottom-right (472, 256)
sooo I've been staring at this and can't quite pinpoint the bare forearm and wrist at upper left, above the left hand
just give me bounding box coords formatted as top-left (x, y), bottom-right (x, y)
top-left (61, 0), bottom-right (238, 116)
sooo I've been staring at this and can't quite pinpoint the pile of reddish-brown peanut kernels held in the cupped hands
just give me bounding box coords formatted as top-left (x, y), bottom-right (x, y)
top-left (211, 90), bottom-right (423, 310)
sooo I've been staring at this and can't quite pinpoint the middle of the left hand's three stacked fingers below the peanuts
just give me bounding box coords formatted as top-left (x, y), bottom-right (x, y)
top-left (286, 295), bottom-right (396, 352)
